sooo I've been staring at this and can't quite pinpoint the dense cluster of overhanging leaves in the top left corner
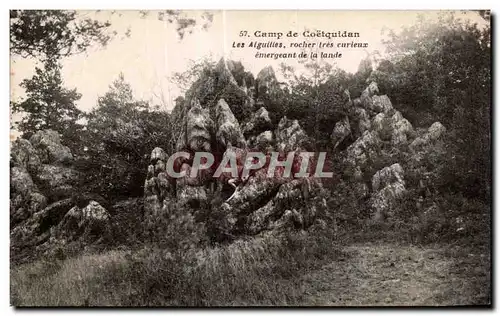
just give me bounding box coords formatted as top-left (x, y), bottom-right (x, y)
top-left (10, 10), bottom-right (111, 60)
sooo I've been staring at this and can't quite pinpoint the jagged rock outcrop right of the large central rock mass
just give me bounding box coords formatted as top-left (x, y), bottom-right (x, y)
top-left (344, 82), bottom-right (446, 221)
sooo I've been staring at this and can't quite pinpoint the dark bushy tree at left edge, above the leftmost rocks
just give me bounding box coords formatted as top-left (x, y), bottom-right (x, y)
top-left (11, 59), bottom-right (82, 138)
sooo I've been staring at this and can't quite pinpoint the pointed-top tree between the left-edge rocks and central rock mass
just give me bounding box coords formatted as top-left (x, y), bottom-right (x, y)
top-left (80, 74), bottom-right (171, 200)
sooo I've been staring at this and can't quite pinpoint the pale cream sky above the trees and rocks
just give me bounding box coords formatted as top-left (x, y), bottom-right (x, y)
top-left (11, 11), bottom-right (488, 120)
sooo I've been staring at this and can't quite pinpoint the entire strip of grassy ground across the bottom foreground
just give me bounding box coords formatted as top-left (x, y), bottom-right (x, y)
top-left (11, 235), bottom-right (490, 306)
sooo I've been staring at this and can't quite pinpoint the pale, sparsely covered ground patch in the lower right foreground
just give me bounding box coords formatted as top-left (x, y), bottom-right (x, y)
top-left (301, 245), bottom-right (489, 306)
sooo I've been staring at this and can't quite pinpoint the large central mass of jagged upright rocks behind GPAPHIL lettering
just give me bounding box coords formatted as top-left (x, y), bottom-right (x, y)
top-left (144, 60), bottom-right (326, 235)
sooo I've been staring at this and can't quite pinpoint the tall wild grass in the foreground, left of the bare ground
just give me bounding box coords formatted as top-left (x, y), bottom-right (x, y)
top-left (12, 226), bottom-right (346, 306)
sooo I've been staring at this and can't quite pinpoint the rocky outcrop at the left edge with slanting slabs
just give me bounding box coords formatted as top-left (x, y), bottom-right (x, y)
top-left (10, 130), bottom-right (109, 255)
